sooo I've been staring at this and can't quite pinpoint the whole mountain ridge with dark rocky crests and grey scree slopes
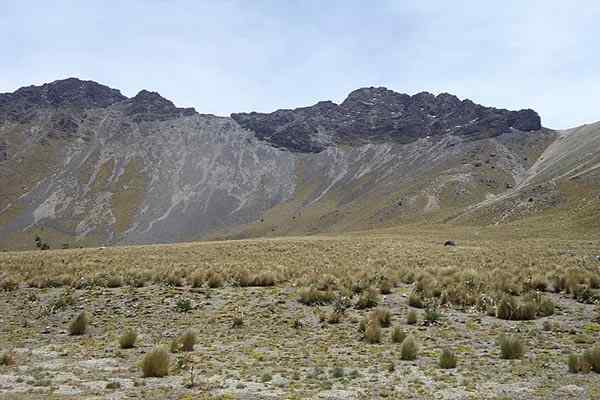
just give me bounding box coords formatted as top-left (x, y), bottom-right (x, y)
top-left (0, 78), bottom-right (600, 248)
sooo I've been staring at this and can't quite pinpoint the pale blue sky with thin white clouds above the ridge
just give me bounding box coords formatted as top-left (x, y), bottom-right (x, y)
top-left (0, 0), bottom-right (600, 129)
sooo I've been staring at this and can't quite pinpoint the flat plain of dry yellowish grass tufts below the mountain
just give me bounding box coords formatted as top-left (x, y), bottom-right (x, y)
top-left (0, 226), bottom-right (600, 400)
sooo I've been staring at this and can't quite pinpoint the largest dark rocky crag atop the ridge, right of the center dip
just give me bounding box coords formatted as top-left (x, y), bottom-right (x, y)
top-left (231, 87), bottom-right (542, 152)
